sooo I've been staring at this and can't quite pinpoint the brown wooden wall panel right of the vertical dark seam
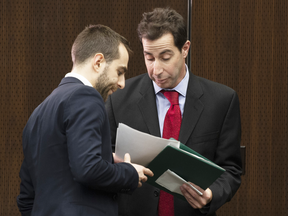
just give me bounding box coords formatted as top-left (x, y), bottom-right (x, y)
top-left (191, 0), bottom-right (288, 216)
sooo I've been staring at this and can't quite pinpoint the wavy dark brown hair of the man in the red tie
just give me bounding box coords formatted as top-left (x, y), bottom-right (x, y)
top-left (137, 8), bottom-right (187, 52)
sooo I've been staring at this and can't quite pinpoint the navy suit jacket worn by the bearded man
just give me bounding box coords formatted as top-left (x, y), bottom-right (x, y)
top-left (17, 77), bottom-right (138, 216)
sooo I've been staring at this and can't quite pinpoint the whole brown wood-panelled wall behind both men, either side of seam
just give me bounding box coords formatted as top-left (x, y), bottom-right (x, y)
top-left (0, 0), bottom-right (288, 216)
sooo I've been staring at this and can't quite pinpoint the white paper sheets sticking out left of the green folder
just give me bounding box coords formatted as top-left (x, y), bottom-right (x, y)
top-left (115, 123), bottom-right (180, 166)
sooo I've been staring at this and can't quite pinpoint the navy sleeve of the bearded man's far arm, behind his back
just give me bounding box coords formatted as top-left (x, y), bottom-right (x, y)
top-left (17, 158), bottom-right (35, 216)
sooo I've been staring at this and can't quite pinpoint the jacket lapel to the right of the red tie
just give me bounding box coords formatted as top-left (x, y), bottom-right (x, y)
top-left (179, 73), bottom-right (204, 144)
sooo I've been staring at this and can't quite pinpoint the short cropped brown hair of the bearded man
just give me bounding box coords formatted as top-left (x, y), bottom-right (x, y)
top-left (71, 24), bottom-right (132, 64)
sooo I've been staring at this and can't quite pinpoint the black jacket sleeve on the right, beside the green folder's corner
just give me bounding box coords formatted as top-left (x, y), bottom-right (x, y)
top-left (209, 92), bottom-right (242, 212)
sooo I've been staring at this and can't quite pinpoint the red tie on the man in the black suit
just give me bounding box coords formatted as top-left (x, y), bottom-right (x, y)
top-left (158, 90), bottom-right (182, 216)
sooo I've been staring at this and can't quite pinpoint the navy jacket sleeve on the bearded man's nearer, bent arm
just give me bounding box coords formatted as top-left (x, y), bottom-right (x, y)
top-left (64, 87), bottom-right (138, 192)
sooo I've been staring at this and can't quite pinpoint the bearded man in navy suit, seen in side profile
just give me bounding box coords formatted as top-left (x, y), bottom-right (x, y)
top-left (17, 25), bottom-right (153, 216)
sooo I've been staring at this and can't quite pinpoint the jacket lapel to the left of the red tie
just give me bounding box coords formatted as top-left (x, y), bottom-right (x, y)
top-left (137, 74), bottom-right (161, 137)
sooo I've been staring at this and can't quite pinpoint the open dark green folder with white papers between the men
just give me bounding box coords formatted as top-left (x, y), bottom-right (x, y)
top-left (116, 123), bottom-right (225, 199)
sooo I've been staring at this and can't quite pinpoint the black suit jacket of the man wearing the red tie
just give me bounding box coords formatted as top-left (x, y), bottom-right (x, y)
top-left (106, 73), bottom-right (241, 216)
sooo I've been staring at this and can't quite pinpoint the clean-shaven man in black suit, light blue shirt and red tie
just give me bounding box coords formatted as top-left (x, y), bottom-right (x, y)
top-left (106, 8), bottom-right (241, 216)
